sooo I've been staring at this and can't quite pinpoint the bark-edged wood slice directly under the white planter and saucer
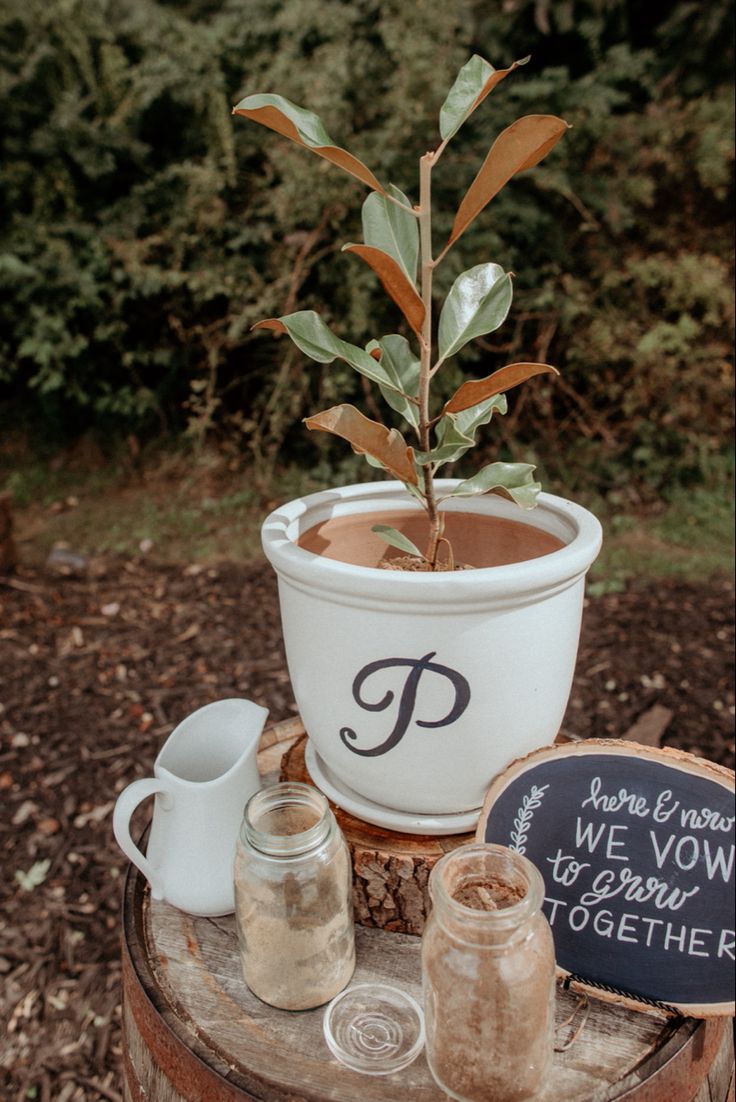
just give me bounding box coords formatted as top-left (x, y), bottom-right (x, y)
top-left (280, 735), bottom-right (474, 934)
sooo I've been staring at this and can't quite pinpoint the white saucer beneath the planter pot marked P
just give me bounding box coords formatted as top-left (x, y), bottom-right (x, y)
top-left (304, 738), bottom-right (480, 835)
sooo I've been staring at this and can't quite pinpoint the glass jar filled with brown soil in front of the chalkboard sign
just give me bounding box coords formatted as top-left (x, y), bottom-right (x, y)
top-left (422, 843), bottom-right (555, 1102)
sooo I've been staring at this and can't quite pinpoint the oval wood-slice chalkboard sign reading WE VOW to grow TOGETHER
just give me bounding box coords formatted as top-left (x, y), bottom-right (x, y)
top-left (477, 739), bottom-right (735, 1017)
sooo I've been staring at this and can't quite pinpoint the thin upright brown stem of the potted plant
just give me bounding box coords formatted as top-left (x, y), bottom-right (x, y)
top-left (418, 153), bottom-right (442, 570)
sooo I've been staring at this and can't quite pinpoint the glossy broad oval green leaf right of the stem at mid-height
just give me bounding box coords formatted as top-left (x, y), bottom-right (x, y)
top-left (439, 264), bottom-right (513, 360)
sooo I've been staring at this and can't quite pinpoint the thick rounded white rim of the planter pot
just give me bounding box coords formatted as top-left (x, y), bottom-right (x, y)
top-left (261, 478), bottom-right (603, 612)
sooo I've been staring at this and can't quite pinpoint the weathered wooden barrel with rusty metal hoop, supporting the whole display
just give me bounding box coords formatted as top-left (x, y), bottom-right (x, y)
top-left (123, 721), bottom-right (733, 1102)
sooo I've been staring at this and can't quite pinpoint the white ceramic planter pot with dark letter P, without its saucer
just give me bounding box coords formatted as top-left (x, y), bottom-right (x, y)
top-left (262, 480), bottom-right (602, 814)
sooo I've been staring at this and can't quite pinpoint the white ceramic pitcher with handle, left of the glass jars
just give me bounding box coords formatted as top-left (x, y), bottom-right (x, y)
top-left (112, 699), bottom-right (268, 917)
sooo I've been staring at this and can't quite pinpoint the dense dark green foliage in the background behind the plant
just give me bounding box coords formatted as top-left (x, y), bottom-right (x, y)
top-left (0, 0), bottom-right (733, 490)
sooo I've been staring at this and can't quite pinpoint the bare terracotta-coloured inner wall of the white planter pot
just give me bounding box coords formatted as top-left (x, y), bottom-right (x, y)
top-left (299, 509), bottom-right (564, 566)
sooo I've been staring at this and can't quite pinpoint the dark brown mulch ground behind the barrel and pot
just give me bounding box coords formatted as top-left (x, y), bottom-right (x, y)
top-left (0, 561), bottom-right (734, 1102)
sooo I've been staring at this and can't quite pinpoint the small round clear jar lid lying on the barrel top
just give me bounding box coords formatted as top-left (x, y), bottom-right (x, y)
top-left (323, 983), bottom-right (424, 1076)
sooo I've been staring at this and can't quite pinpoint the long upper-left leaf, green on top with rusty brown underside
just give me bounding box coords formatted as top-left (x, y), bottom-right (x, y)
top-left (232, 94), bottom-right (383, 192)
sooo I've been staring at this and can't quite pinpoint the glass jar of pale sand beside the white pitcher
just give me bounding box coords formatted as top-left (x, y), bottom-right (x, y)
top-left (235, 781), bottom-right (355, 1011)
